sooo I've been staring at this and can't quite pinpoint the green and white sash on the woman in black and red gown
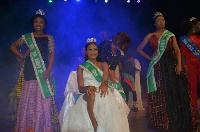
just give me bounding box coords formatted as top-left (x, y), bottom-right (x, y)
top-left (146, 30), bottom-right (174, 93)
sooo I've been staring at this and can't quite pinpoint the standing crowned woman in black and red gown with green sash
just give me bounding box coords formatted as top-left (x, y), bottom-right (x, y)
top-left (137, 12), bottom-right (193, 131)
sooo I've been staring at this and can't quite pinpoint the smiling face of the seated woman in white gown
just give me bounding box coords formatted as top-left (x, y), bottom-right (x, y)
top-left (85, 43), bottom-right (98, 59)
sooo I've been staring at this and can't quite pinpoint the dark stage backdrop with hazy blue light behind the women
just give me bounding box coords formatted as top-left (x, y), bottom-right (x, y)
top-left (0, 0), bottom-right (200, 131)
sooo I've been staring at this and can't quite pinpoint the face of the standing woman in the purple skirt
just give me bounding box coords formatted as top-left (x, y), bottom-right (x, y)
top-left (33, 17), bottom-right (45, 31)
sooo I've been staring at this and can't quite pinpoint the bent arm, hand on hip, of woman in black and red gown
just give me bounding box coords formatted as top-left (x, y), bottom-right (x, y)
top-left (137, 33), bottom-right (152, 60)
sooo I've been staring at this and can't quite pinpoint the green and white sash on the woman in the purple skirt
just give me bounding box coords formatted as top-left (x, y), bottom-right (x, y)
top-left (22, 33), bottom-right (55, 98)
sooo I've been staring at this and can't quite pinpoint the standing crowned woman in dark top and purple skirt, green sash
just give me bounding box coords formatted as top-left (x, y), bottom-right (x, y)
top-left (10, 9), bottom-right (59, 132)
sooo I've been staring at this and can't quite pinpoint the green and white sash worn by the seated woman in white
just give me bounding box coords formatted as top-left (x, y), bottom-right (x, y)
top-left (81, 61), bottom-right (126, 100)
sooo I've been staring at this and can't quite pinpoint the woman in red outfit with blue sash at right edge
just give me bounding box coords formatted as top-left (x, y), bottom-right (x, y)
top-left (179, 17), bottom-right (200, 109)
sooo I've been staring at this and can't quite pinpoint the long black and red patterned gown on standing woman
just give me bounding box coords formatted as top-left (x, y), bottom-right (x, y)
top-left (146, 35), bottom-right (194, 131)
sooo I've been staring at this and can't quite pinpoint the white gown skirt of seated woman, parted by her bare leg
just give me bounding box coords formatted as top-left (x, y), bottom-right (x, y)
top-left (61, 89), bottom-right (130, 132)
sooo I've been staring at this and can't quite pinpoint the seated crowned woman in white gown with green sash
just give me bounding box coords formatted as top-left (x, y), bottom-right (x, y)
top-left (59, 38), bottom-right (130, 132)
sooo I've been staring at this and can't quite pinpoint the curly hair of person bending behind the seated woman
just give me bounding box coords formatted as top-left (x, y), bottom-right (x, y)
top-left (112, 32), bottom-right (131, 51)
